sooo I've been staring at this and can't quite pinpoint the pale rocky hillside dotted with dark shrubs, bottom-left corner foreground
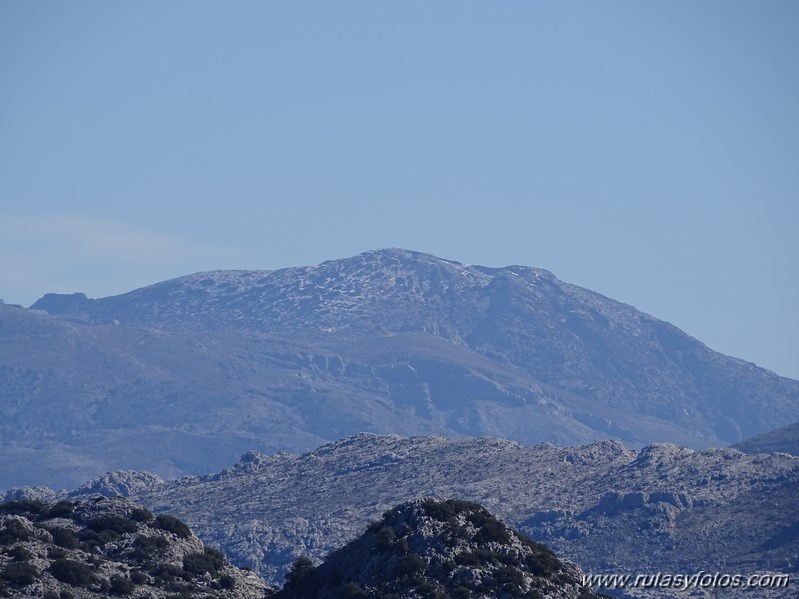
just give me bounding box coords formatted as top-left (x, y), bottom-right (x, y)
top-left (0, 499), bottom-right (267, 599)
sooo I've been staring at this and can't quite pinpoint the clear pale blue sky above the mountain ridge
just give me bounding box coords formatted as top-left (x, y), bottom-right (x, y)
top-left (0, 0), bottom-right (799, 378)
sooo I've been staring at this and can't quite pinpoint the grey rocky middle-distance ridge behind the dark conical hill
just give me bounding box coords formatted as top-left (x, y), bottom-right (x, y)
top-left (95, 434), bottom-right (799, 582)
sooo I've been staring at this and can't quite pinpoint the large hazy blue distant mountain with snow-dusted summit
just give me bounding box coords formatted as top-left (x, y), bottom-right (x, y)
top-left (0, 250), bottom-right (799, 487)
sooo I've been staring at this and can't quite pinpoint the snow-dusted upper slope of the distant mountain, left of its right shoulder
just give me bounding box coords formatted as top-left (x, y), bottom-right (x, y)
top-left (33, 249), bottom-right (500, 333)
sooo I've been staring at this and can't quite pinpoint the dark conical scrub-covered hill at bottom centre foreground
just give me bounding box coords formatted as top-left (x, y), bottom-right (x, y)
top-left (275, 498), bottom-right (596, 599)
